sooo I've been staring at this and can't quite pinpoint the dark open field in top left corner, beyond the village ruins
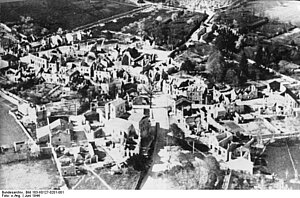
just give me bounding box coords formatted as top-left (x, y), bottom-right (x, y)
top-left (0, 0), bottom-right (136, 32)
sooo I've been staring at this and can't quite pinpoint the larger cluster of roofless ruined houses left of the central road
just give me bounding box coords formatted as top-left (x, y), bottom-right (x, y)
top-left (1, 24), bottom-right (158, 176)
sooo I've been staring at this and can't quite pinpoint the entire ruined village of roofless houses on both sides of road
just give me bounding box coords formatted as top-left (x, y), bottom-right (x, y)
top-left (0, 1), bottom-right (300, 179)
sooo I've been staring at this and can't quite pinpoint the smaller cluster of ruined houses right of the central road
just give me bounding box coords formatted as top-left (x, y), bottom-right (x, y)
top-left (170, 75), bottom-right (300, 174)
